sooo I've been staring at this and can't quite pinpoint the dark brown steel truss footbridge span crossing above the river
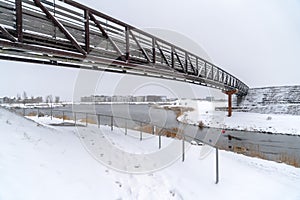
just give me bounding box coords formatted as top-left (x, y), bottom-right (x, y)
top-left (0, 0), bottom-right (249, 96)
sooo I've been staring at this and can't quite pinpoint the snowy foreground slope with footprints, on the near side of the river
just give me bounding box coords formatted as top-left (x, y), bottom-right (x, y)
top-left (0, 108), bottom-right (300, 200)
